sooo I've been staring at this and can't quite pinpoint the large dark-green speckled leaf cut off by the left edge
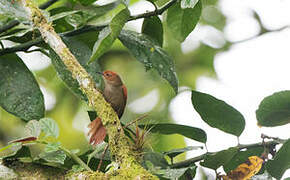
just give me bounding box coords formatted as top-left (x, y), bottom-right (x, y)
top-left (0, 54), bottom-right (45, 121)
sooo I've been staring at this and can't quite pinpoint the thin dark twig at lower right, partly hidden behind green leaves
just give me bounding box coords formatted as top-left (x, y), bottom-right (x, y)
top-left (170, 140), bottom-right (285, 168)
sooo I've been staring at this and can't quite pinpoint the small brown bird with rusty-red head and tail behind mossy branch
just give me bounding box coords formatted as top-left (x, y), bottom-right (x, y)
top-left (88, 70), bottom-right (127, 145)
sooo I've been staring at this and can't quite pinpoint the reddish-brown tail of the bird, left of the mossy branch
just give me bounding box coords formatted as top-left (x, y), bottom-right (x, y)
top-left (88, 117), bottom-right (106, 145)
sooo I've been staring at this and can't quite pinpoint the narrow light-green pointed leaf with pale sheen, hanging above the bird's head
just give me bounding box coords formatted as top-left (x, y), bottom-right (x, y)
top-left (89, 8), bottom-right (130, 62)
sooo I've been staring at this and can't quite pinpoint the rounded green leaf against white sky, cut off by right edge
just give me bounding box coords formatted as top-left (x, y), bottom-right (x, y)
top-left (256, 91), bottom-right (290, 127)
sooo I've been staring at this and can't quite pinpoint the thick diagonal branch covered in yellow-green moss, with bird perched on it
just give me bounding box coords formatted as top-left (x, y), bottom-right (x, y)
top-left (21, 0), bottom-right (157, 179)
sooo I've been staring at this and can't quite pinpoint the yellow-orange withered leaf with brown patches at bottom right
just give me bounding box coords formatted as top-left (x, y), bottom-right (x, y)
top-left (222, 156), bottom-right (264, 180)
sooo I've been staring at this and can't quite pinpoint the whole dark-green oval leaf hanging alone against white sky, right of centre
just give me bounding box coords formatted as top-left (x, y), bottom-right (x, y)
top-left (191, 91), bottom-right (245, 136)
